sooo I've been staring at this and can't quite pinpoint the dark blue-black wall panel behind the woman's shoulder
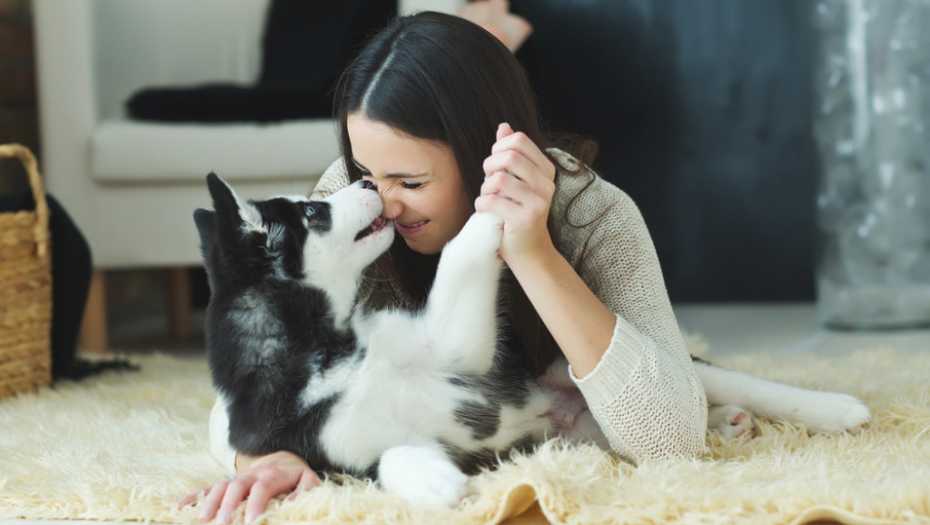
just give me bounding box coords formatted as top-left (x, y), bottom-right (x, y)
top-left (510, 0), bottom-right (817, 301)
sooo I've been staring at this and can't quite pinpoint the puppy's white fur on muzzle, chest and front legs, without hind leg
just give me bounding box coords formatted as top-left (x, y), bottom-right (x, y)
top-left (303, 190), bottom-right (552, 505)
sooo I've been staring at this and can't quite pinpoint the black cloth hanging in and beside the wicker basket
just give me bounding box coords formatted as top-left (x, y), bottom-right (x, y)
top-left (0, 191), bottom-right (129, 380)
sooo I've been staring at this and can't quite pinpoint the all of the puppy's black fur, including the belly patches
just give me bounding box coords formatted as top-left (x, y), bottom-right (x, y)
top-left (194, 173), bottom-right (537, 479)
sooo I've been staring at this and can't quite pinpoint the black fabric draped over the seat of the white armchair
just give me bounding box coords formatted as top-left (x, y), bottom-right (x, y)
top-left (126, 0), bottom-right (397, 122)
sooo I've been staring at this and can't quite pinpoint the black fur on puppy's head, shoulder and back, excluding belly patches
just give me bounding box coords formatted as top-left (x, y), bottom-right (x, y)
top-left (194, 174), bottom-right (358, 472)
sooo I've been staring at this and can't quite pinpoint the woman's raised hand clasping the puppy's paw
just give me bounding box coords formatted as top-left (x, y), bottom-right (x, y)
top-left (475, 123), bottom-right (555, 267)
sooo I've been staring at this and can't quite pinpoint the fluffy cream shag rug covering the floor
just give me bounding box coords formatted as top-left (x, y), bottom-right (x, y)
top-left (0, 342), bottom-right (930, 525)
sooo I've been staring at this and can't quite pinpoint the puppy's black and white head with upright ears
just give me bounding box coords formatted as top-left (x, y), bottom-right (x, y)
top-left (194, 173), bottom-right (394, 290)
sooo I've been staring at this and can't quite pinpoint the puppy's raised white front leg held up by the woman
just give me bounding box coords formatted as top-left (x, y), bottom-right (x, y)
top-left (419, 213), bottom-right (503, 375)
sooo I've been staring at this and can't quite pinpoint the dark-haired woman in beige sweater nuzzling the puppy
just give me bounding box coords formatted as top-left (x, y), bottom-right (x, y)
top-left (185, 13), bottom-right (707, 524)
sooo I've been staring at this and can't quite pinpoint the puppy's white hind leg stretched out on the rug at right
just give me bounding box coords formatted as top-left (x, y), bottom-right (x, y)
top-left (694, 361), bottom-right (872, 433)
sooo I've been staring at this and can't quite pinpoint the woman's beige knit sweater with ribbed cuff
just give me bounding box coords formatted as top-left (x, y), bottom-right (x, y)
top-left (210, 150), bottom-right (707, 468)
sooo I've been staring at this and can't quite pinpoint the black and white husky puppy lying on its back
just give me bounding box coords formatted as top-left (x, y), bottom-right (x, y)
top-left (194, 174), bottom-right (869, 506)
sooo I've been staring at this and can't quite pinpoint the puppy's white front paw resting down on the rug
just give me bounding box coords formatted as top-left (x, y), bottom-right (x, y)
top-left (378, 446), bottom-right (468, 508)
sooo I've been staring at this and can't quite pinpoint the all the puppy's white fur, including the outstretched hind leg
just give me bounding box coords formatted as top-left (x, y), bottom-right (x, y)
top-left (216, 179), bottom-right (870, 506)
